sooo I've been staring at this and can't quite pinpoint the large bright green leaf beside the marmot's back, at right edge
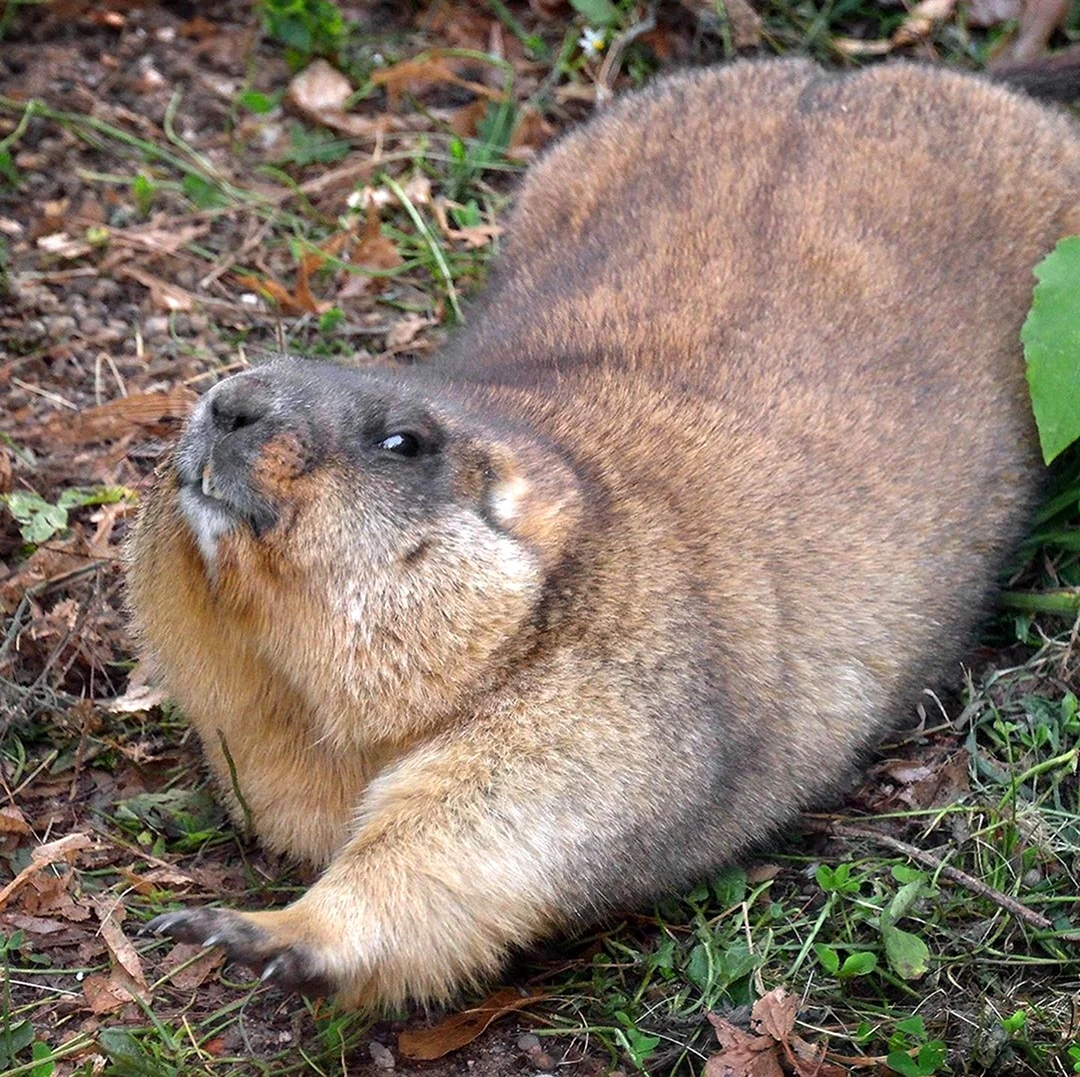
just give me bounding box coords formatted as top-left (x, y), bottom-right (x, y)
top-left (1020, 235), bottom-right (1080, 463)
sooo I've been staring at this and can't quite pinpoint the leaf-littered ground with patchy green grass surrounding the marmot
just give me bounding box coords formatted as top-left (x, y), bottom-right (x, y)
top-left (0, 0), bottom-right (1080, 1077)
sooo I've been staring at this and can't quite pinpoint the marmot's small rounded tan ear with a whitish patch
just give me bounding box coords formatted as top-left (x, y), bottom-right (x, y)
top-left (485, 442), bottom-right (582, 568)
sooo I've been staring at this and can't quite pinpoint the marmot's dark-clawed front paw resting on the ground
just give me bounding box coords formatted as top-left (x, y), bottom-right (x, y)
top-left (145, 907), bottom-right (333, 997)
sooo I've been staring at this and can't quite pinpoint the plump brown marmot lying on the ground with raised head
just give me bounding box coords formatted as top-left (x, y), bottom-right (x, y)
top-left (131, 60), bottom-right (1080, 1006)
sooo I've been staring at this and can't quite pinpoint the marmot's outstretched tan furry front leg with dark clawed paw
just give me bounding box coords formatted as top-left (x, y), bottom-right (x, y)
top-left (151, 712), bottom-right (629, 1006)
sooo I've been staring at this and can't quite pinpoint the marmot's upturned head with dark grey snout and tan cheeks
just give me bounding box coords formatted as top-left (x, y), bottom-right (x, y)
top-left (133, 360), bottom-right (580, 741)
